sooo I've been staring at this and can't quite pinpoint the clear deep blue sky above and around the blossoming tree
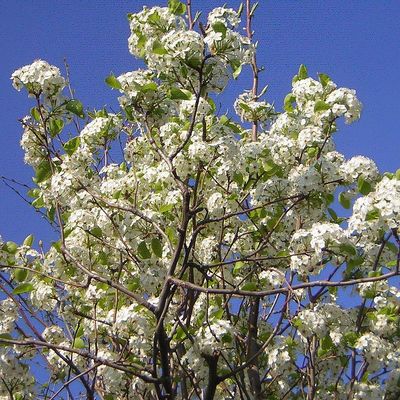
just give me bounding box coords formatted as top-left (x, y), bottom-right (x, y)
top-left (0, 0), bottom-right (400, 243)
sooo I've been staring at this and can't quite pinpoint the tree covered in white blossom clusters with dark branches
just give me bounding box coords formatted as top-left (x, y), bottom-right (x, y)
top-left (0, 0), bottom-right (400, 400)
